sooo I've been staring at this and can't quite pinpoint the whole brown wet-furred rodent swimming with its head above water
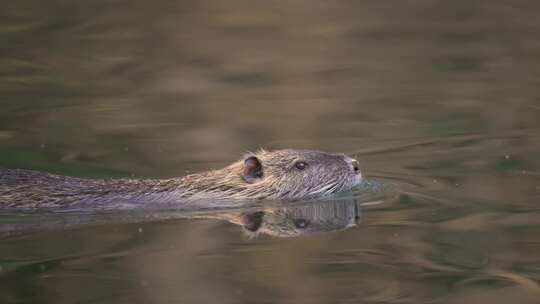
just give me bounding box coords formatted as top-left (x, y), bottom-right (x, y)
top-left (0, 149), bottom-right (362, 209)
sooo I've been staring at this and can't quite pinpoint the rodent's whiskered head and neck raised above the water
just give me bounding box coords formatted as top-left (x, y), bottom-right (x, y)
top-left (183, 149), bottom-right (362, 200)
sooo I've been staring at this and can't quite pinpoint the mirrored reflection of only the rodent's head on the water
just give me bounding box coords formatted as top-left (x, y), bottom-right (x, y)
top-left (199, 200), bottom-right (360, 237)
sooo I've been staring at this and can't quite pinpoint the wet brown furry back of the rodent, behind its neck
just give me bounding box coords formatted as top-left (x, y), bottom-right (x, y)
top-left (0, 169), bottom-right (189, 209)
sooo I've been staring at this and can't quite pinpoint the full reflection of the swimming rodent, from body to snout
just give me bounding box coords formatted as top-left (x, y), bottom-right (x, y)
top-left (0, 199), bottom-right (360, 238)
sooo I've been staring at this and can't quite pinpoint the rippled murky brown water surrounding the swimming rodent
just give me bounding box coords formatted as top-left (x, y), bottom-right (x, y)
top-left (0, 0), bottom-right (540, 304)
